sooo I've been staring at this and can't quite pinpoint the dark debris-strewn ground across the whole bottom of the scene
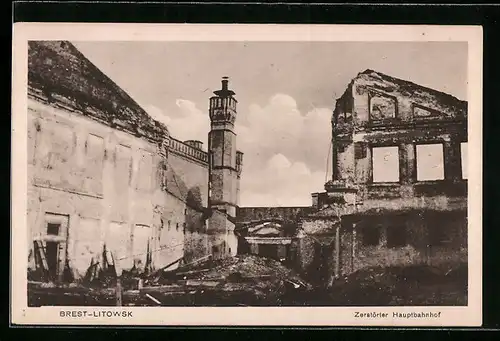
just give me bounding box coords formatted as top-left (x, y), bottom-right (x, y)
top-left (28, 255), bottom-right (467, 306)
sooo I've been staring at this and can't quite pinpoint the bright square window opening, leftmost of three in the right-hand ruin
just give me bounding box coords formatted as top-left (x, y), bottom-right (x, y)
top-left (372, 146), bottom-right (399, 182)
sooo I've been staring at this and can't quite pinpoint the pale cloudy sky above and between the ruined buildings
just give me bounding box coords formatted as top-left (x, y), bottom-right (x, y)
top-left (75, 42), bottom-right (467, 206)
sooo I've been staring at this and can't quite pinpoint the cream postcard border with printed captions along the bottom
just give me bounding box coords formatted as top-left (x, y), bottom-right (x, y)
top-left (11, 23), bottom-right (483, 326)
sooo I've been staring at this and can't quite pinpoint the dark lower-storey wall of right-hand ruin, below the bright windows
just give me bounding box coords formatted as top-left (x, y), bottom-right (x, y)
top-left (292, 210), bottom-right (467, 285)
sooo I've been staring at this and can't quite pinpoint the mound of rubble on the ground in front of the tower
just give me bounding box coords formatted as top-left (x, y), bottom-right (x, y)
top-left (136, 255), bottom-right (312, 306)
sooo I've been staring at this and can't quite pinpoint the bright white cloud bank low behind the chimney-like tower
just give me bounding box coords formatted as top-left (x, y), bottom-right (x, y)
top-left (141, 94), bottom-right (331, 206)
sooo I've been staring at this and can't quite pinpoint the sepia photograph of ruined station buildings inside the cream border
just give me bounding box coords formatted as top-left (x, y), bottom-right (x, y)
top-left (13, 25), bottom-right (482, 324)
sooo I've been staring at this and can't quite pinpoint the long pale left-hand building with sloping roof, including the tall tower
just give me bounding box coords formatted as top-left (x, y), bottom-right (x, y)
top-left (27, 41), bottom-right (243, 281)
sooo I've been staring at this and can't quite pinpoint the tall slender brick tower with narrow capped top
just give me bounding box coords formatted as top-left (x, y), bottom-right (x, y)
top-left (208, 77), bottom-right (243, 255)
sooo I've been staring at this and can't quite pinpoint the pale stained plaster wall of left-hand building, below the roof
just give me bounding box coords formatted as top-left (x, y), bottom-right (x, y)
top-left (28, 100), bottom-right (212, 279)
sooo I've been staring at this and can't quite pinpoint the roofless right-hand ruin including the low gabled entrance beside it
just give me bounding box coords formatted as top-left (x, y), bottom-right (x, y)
top-left (238, 70), bottom-right (467, 285)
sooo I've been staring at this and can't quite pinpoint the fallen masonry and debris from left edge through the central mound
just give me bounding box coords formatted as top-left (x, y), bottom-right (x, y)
top-left (28, 255), bottom-right (312, 306)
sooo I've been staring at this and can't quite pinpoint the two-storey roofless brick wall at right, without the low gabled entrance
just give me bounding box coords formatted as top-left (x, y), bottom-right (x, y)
top-left (319, 70), bottom-right (467, 278)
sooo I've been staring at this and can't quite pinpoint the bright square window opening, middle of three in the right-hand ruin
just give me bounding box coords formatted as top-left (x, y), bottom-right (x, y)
top-left (417, 144), bottom-right (444, 181)
